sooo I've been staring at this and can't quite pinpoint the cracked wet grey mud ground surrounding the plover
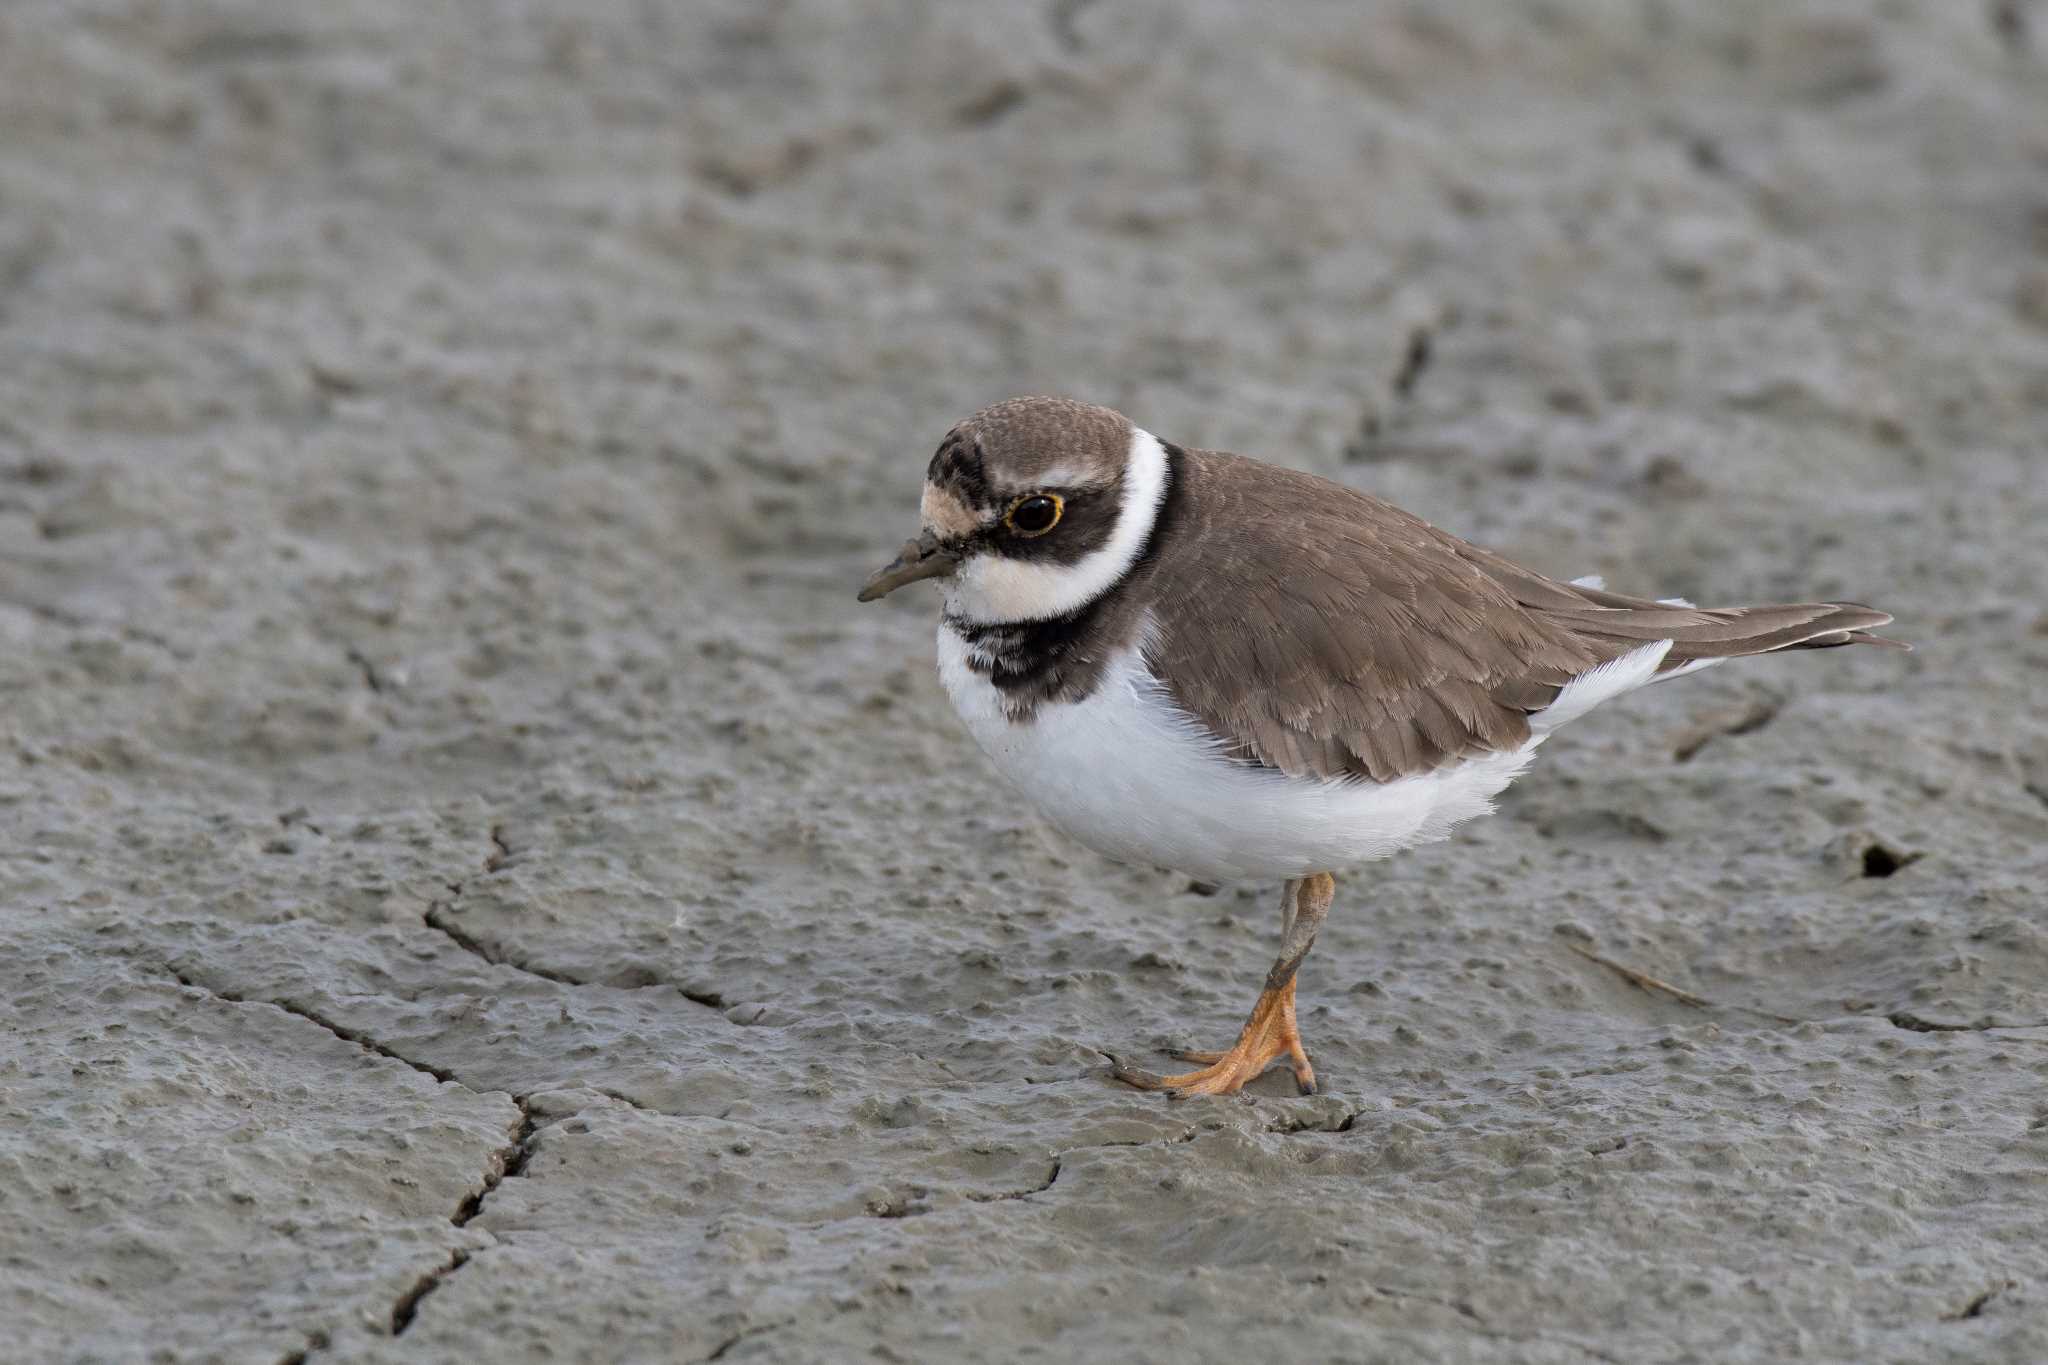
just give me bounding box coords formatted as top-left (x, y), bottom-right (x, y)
top-left (0, 0), bottom-right (2048, 1365)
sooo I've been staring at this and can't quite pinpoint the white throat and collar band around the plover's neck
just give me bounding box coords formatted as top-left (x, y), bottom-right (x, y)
top-left (946, 428), bottom-right (1165, 624)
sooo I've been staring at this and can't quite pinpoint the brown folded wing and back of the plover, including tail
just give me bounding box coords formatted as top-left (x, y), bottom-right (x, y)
top-left (1147, 450), bottom-right (1890, 782)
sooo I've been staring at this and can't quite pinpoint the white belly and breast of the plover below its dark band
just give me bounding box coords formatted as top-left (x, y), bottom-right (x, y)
top-left (938, 624), bottom-right (1548, 880)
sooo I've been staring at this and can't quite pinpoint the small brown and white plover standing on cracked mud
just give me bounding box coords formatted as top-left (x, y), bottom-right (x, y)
top-left (860, 397), bottom-right (1892, 1095)
